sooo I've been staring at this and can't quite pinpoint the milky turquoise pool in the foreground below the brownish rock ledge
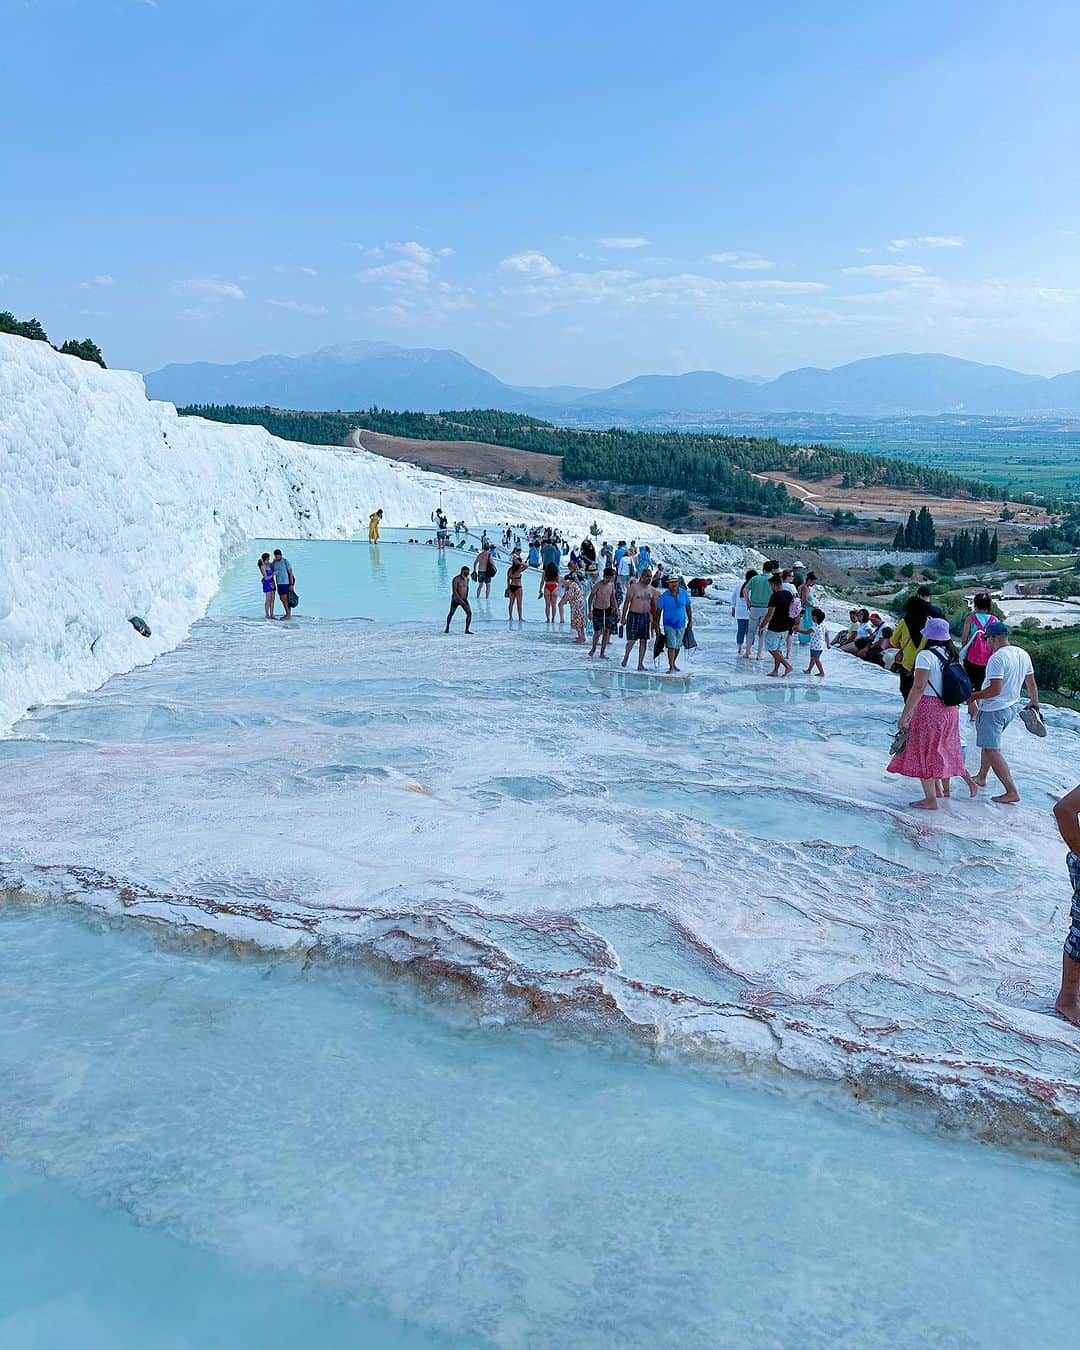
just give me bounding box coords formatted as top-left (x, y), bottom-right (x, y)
top-left (0, 907), bottom-right (1080, 1350)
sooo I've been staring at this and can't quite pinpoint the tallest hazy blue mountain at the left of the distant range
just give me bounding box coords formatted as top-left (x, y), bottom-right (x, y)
top-left (146, 342), bottom-right (547, 413)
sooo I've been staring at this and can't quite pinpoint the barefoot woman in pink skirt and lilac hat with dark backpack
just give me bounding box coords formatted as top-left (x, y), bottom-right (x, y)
top-left (888, 618), bottom-right (979, 811)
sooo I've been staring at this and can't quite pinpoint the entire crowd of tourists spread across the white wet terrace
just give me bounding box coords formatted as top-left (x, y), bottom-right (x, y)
top-left (258, 508), bottom-right (1080, 1026)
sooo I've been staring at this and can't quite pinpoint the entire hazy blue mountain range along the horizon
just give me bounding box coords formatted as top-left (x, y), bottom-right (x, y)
top-left (146, 342), bottom-right (1080, 423)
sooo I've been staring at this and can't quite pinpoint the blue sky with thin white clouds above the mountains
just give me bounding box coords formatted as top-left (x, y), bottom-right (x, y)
top-left (0, 0), bottom-right (1080, 387)
